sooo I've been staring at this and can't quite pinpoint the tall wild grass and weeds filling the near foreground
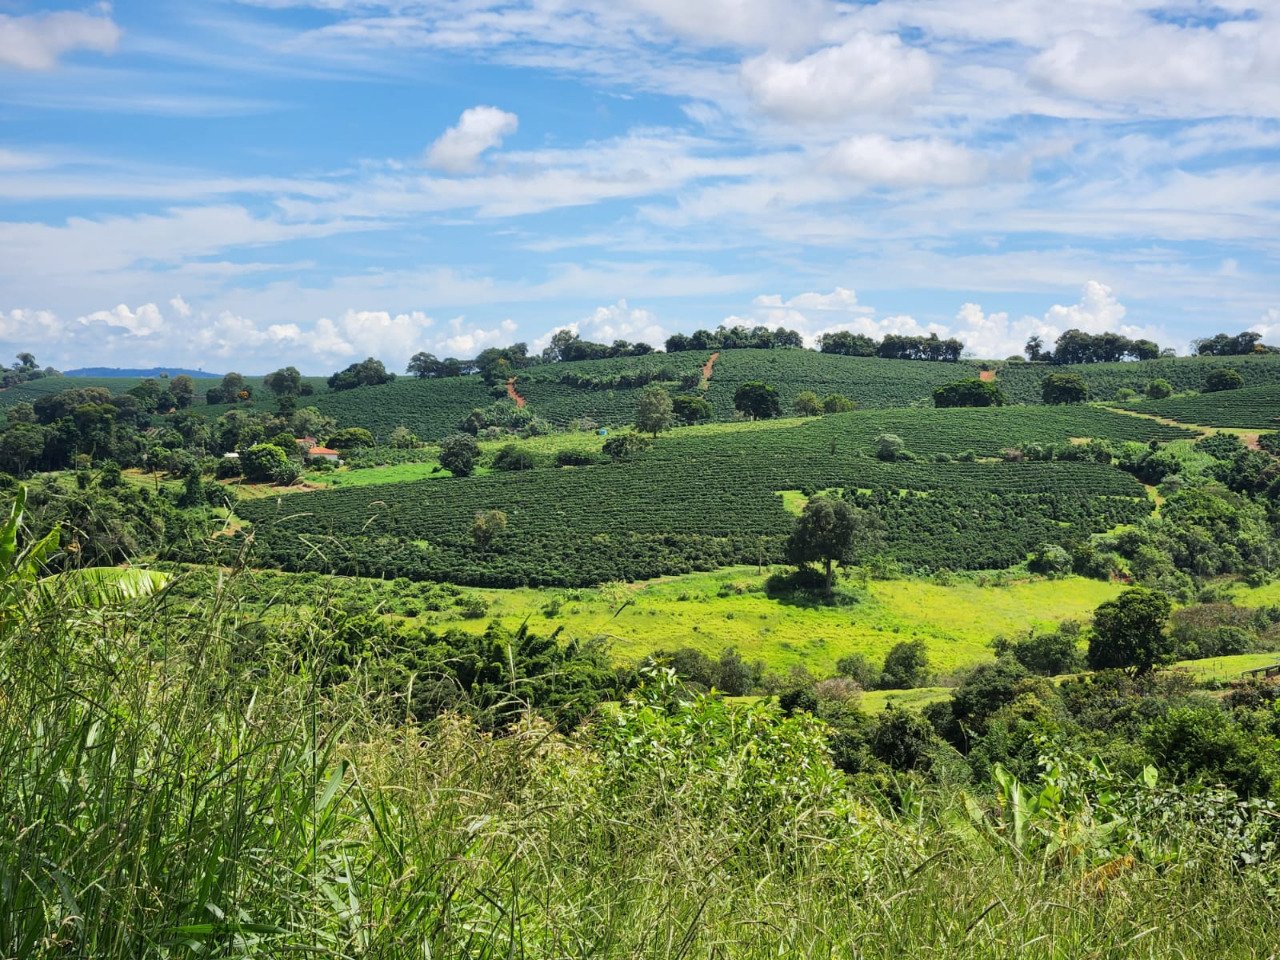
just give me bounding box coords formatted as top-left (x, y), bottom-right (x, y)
top-left (0, 568), bottom-right (1280, 959)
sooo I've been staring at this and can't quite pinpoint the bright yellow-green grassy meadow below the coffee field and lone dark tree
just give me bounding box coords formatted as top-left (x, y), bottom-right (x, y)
top-left (440, 567), bottom-right (1120, 672)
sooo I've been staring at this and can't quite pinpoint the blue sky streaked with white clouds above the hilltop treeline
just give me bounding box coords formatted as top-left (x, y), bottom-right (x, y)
top-left (0, 0), bottom-right (1280, 372)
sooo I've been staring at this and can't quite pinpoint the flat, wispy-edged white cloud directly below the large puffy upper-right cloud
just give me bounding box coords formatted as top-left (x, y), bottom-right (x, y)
top-left (824, 133), bottom-right (989, 187)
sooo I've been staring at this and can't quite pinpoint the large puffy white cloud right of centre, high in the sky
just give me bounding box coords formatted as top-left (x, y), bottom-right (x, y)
top-left (741, 32), bottom-right (936, 123)
